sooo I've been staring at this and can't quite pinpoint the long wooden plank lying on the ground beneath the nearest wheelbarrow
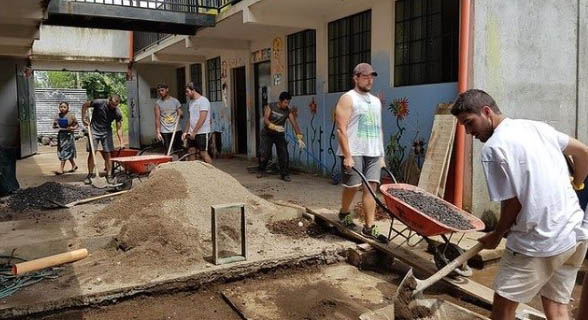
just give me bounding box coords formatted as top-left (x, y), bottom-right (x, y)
top-left (308, 209), bottom-right (545, 317)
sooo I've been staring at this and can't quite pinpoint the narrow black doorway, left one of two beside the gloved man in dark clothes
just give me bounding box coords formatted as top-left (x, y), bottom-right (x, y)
top-left (233, 67), bottom-right (247, 154)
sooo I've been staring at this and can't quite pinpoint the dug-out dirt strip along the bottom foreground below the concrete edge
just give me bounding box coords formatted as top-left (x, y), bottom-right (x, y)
top-left (24, 264), bottom-right (489, 320)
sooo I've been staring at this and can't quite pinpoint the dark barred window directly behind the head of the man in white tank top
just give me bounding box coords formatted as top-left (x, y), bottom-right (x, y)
top-left (328, 10), bottom-right (372, 92)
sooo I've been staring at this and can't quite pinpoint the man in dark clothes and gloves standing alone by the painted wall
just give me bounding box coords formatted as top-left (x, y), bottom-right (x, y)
top-left (257, 91), bottom-right (306, 182)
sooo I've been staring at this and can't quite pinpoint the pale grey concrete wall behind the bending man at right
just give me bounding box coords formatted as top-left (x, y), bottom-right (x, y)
top-left (472, 0), bottom-right (587, 215)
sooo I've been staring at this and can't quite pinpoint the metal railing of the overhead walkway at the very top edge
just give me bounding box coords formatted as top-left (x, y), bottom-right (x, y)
top-left (69, 0), bottom-right (234, 14)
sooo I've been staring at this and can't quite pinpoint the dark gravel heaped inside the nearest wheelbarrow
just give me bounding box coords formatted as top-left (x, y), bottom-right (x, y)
top-left (388, 188), bottom-right (474, 230)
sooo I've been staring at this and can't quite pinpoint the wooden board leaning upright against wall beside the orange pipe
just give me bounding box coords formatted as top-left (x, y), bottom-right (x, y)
top-left (418, 114), bottom-right (457, 197)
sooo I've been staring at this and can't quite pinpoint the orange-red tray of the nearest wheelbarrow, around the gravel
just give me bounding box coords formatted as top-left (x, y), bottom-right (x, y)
top-left (380, 183), bottom-right (484, 237)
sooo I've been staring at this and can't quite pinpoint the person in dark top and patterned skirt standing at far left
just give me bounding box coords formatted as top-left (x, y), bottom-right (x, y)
top-left (53, 101), bottom-right (79, 175)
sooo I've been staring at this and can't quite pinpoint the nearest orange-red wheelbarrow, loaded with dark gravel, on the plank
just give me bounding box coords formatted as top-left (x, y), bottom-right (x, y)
top-left (352, 168), bottom-right (485, 276)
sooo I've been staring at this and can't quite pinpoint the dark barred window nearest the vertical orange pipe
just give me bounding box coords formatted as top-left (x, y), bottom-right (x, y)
top-left (394, 0), bottom-right (459, 86)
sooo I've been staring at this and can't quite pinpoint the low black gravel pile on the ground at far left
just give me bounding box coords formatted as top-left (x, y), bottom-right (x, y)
top-left (8, 182), bottom-right (105, 211)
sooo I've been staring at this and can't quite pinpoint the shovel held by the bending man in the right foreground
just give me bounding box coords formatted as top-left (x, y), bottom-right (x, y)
top-left (394, 242), bottom-right (484, 301)
